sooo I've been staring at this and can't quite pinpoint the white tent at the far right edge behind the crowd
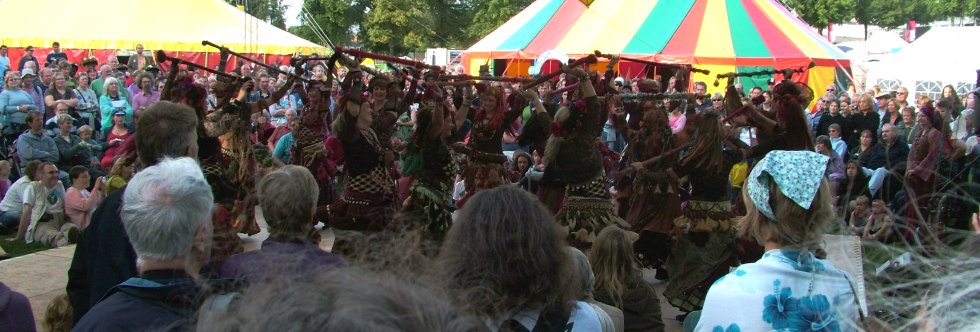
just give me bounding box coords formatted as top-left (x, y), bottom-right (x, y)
top-left (867, 27), bottom-right (980, 102)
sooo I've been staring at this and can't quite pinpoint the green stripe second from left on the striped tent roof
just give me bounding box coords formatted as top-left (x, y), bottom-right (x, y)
top-left (623, 0), bottom-right (696, 54)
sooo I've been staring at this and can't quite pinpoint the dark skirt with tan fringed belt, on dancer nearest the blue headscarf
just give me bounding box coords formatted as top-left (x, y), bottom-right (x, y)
top-left (664, 201), bottom-right (738, 312)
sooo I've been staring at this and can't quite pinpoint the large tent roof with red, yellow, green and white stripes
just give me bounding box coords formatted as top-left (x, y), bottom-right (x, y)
top-left (463, 0), bottom-right (850, 95)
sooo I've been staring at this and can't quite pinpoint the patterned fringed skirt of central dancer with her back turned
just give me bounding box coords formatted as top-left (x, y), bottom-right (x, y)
top-left (555, 172), bottom-right (629, 249)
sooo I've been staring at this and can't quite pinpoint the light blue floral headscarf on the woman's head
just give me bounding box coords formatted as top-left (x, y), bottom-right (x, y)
top-left (747, 150), bottom-right (830, 222)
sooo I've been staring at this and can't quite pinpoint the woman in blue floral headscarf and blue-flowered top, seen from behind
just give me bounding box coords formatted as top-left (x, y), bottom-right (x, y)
top-left (691, 151), bottom-right (860, 331)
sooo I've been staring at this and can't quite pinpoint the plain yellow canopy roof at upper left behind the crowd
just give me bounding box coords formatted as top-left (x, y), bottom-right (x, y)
top-left (0, 0), bottom-right (329, 54)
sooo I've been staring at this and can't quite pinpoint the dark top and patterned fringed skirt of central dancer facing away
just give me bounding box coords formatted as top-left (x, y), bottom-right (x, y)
top-left (542, 95), bottom-right (629, 249)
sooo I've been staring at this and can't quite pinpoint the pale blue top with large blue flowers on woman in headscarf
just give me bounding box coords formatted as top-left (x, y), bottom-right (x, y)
top-left (695, 249), bottom-right (858, 332)
